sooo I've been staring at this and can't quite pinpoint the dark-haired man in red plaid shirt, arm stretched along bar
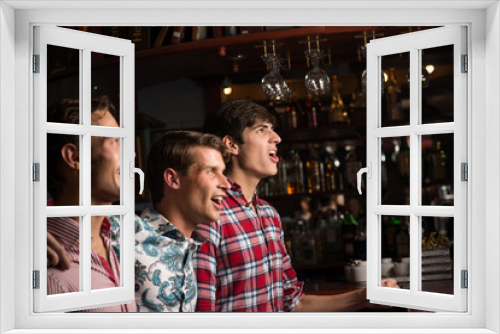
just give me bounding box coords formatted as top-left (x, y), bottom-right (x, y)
top-left (194, 100), bottom-right (397, 312)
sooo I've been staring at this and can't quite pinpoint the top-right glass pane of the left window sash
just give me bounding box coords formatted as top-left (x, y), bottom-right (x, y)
top-left (91, 52), bottom-right (120, 126)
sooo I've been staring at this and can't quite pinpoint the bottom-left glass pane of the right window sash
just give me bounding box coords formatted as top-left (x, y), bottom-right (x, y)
top-left (380, 216), bottom-right (410, 289)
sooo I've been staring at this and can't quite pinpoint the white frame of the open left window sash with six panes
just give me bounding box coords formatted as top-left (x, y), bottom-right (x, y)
top-left (33, 26), bottom-right (135, 312)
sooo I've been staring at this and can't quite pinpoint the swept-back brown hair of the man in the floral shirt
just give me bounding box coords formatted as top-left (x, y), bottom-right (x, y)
top-left (146, 131), bottom-right (228, 204)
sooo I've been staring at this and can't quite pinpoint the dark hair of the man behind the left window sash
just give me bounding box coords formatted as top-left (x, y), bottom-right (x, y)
top-left (47, 96), bottom-right (118, 199)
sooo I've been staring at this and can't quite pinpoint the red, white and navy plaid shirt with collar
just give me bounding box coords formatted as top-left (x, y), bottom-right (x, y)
top-left (193, 180), bottom-right (303, 312)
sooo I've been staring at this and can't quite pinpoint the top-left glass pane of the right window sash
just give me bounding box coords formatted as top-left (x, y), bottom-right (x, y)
top-left (381, 52), bottom-right (410, 126)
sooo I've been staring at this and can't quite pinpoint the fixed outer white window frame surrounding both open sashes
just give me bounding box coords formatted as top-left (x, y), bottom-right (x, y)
top-left (0, 0), bottom-right (500, 333)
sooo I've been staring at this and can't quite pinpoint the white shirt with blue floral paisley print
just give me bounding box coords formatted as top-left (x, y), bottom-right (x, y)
top-left (112, 208), bottom-right (204, 312)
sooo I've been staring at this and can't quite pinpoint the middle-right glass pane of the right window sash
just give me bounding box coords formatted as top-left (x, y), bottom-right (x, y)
top-left (422, 134), bottom-right (454, 206)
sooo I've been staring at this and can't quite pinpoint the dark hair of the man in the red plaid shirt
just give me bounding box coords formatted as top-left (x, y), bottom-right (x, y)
top-left (203, 100), bottom-right (274, 144)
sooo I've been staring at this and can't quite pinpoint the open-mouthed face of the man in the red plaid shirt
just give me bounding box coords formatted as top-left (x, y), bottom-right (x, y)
top-left (237, 120), bottom-right (281, 179)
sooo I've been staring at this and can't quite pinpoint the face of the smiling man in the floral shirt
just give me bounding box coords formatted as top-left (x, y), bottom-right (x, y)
top-left (177, 147), bottom-right (229, 224)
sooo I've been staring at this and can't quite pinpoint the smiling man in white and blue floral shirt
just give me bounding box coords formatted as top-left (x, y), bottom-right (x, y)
top-left (128, 131), bottom-right (229, 312)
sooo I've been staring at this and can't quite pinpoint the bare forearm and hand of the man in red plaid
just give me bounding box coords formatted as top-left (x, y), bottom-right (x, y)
top-left (294, 279), bottom-right (399, 312)
